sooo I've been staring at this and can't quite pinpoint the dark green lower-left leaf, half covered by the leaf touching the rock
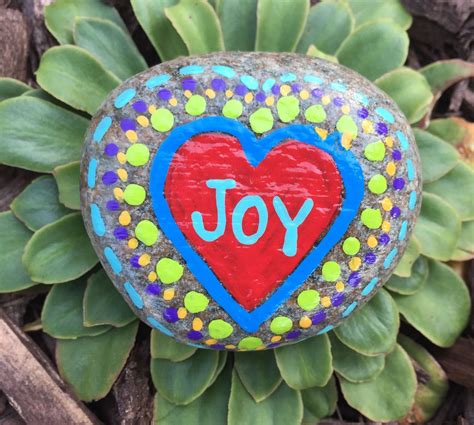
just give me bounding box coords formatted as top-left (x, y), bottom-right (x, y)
top-left (41, 279), bottom-right (110, 339)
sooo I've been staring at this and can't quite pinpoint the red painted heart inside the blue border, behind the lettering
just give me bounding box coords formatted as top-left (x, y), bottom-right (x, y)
top-left (164, 133), bottom-right (343, 311)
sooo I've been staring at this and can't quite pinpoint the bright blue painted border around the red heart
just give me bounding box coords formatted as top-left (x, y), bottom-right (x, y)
top-left (149, 116), bottom-right (364, 333)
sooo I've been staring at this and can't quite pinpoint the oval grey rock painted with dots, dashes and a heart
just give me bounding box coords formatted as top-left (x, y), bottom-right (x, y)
top-left (81, 53), bottom-right (421, 350)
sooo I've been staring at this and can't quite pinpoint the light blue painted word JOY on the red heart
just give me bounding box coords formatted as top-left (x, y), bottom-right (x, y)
top-left (191, 179), bottom-right (314, 257)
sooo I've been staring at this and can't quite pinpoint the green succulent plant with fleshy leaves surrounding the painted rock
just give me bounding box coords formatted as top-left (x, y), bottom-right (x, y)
top-left (0, 0), bottom-right (474, 425)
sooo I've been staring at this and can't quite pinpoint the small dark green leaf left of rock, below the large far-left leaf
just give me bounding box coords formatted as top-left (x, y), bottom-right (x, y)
top-left (11, 176), bottom-right (71, 231)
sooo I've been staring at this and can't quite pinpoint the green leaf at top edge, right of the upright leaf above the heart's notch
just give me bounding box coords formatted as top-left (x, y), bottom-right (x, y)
top-left (296, 1), bottom-right (354, 55)
